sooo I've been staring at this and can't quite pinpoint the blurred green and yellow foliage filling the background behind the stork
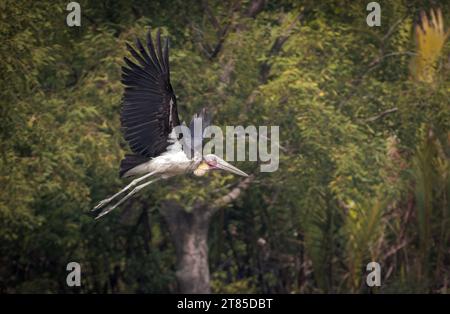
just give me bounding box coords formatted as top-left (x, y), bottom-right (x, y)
top-left (0, 0), bottom-right (450, 293)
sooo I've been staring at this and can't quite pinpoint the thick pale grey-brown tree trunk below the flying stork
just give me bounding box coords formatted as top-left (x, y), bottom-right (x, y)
top-left (162, 203), bottom-right (211, 293)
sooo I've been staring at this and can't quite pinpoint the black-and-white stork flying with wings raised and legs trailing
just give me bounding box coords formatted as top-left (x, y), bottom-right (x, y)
top-left (93, 30), bottom-right (247, 218)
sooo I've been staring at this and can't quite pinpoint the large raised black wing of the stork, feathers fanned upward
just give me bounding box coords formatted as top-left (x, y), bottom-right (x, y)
top-left (121, 30), bottom-right (180, 162)
